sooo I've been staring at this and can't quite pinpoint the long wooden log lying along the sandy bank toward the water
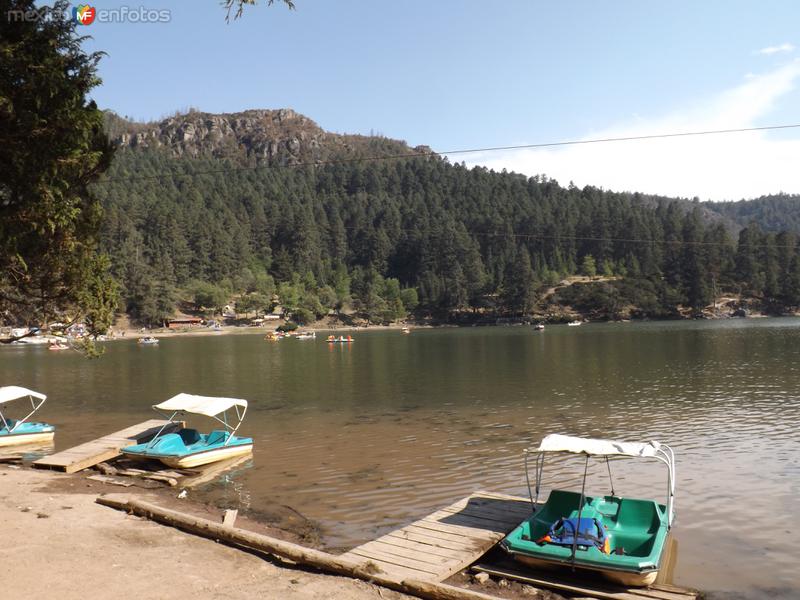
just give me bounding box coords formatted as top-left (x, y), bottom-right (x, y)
top-left (97, 496), bottom-right (497, 600)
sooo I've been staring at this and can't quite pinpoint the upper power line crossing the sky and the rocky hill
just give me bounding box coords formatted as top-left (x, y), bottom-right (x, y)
top-left (94, 123), bottom-right (800, 185)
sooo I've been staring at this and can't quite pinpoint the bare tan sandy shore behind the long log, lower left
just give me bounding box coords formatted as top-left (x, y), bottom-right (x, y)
top-left (0, 466), bottom-right (408, 600)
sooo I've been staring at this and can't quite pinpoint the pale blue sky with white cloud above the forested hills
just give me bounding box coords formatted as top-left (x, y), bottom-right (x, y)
top-left (79, 0), bottom-right (800, 200)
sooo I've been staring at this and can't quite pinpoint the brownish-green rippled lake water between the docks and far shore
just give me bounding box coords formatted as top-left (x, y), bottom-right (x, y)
top-left (0, 319), bottom-right (800, 598)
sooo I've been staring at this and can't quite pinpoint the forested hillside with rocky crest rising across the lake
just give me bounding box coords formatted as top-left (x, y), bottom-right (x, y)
top-left (94, 111), bottom-right (800, 323)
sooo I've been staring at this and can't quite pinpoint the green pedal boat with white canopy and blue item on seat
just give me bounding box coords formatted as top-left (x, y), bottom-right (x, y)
top-left (500, 434), bottom-right (675, 587)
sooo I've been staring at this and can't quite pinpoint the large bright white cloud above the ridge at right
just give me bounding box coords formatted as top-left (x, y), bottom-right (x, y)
top-left (452, 61), bottom-right (800, 200)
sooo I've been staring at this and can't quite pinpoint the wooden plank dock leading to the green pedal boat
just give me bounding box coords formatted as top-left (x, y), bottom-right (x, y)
top-left (342, 492), bottom-right (531, 582)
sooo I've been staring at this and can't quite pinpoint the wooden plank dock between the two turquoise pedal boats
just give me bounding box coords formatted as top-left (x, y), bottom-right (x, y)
top-left (33, 419), bottom-right (184, 473)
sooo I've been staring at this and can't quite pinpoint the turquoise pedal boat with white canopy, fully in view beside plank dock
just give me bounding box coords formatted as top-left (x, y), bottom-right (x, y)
top-left (122, 394), bottom-right (253, 468)
